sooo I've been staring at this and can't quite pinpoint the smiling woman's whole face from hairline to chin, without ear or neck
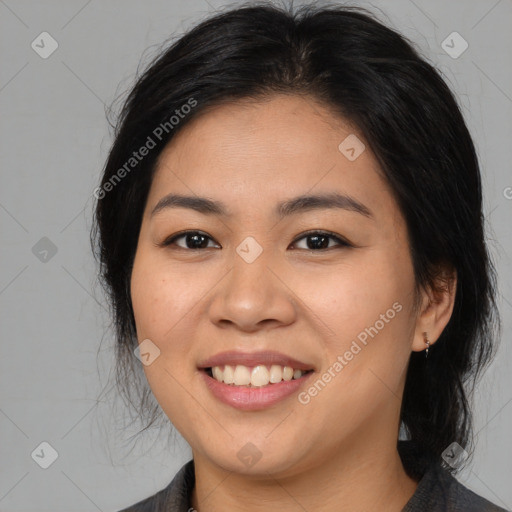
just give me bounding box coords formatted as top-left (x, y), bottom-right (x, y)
top-left (131, 95), bottom-right (417, 475)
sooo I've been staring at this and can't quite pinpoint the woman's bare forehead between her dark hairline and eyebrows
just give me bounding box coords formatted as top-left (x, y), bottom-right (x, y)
top-left (148, 95), bottom-right (393, 218)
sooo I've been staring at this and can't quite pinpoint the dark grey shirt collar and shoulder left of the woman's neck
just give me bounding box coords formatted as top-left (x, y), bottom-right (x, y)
top-left (118, 460), bottom-right (195, 512)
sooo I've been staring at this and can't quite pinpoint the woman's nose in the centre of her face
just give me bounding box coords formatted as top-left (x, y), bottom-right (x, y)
top-left (209, 243), bottom-right (297, 332)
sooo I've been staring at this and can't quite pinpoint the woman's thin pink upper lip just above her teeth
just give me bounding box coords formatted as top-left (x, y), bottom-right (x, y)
top-left (198, 350), bottom-right (313, 370)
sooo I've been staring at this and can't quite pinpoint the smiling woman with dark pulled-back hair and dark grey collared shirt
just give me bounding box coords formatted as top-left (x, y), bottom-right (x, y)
top-left (93, 4), bottom-right (503, 512)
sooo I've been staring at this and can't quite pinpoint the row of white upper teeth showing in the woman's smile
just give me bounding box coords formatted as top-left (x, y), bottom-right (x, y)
top-left (211, 364), bottom-right (306, 387)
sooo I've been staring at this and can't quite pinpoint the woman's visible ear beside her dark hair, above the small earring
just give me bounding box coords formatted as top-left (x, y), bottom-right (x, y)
top-left (412, 267), bottom-right (457, 352)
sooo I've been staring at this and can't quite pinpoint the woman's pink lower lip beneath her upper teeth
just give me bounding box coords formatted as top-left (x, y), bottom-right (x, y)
top-left (201, 371), bottom-right (313, 411)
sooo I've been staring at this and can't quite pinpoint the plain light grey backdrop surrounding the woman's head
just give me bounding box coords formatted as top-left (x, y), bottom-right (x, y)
top-left (0, 0), bottom-right (512, 512)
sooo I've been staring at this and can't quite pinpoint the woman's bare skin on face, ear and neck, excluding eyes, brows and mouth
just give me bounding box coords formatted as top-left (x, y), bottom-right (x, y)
top-left (131, 95), bottom-right (455, 512)
